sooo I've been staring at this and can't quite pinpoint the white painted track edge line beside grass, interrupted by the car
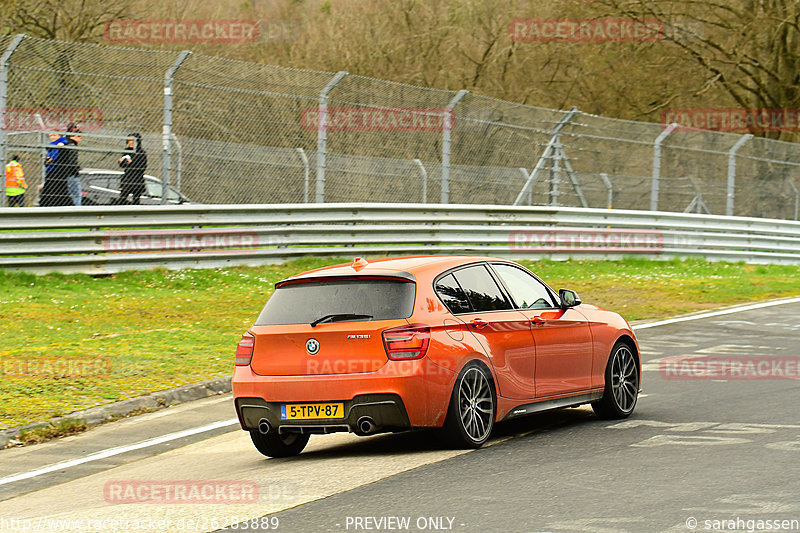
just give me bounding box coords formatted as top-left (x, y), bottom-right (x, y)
top-left (6, 298), bottom-right (800, 485)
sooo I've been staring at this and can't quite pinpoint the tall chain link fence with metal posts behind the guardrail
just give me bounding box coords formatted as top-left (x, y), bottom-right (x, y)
top-left (0, 36), bottom-right (800, 219)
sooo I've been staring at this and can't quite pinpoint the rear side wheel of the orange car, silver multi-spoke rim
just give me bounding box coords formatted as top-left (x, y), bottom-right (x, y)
top-left (442, 361), bottom-right (497, 448)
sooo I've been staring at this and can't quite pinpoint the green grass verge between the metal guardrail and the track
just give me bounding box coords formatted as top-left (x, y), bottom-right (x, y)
top-left (0, 258), bottom-right (800, 428)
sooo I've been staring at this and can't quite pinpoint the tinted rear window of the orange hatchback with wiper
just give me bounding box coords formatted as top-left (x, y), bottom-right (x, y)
top-left (255, 279), bottom-right (416, 326)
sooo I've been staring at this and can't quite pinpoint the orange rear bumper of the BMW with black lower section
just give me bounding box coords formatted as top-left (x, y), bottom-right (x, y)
top-left (233, 357), bottom-right (456, 432)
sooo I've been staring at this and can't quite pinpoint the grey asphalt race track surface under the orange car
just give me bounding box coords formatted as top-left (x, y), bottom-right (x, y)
top-left (0, 299), bottom-right (800, 532)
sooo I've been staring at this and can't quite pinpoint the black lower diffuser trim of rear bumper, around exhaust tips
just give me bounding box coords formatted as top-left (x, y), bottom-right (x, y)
top-left (235, 394), bottom-right (411, 434)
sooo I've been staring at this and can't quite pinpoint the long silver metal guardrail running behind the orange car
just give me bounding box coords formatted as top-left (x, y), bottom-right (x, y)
top-left (0, 204), bottom-right (800, 274)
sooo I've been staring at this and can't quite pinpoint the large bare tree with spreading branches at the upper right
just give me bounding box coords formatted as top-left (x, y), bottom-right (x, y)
top-left (604, 0), bottom-right (800, 137)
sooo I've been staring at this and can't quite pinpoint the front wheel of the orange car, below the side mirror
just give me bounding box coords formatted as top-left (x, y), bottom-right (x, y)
top-left (592, 342), bottom-right (639, 420)
